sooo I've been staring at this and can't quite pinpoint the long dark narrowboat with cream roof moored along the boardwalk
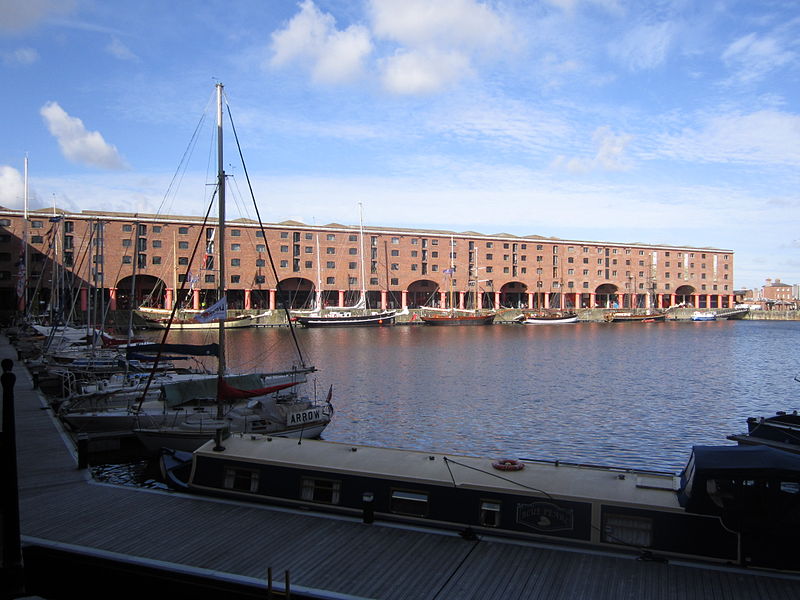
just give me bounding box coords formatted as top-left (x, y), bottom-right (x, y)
top-left (161, 434), bottom-right (800, 571)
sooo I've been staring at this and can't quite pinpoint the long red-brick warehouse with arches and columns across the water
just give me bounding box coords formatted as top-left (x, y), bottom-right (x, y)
top-left (0, 208), bottom-right (736, 312)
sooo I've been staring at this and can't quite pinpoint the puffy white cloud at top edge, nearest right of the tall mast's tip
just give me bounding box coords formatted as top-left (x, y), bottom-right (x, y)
top-left (270, 0), bottom-right (372, 83)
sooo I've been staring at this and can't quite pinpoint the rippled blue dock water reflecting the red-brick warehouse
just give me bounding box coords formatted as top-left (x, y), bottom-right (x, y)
top-left (134, 321), bottom-right (800, 471)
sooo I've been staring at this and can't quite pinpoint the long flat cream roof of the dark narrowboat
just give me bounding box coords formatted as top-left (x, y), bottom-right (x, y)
top-left (194, 434), bottom-right (683, 511)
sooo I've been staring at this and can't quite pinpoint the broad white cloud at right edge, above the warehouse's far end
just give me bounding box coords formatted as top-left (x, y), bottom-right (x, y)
top-left (659, 110), bottom-right (800, 166)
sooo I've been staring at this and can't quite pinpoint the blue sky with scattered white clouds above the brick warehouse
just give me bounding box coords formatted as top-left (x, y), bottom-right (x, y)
top-left (0, 0), bottom-right (800, 288)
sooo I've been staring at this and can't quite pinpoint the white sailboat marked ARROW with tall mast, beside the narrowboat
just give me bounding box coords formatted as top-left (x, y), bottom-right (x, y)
top-left (133, 83), bottom-right (333, 452)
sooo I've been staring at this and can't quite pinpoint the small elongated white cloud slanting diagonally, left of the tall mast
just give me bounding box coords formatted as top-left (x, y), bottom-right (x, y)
top-left (39, 102), bottom-right (125, 169)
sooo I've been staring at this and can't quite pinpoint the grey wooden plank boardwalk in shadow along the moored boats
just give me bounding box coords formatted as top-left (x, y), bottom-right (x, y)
top-left (0, 336), bottom-right (800, 600)
